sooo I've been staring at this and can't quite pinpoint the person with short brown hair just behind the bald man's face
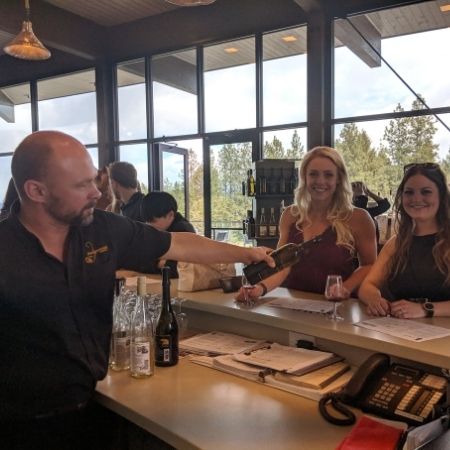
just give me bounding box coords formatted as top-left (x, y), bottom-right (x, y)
top-left (109, 161), bottom-right (144, 222)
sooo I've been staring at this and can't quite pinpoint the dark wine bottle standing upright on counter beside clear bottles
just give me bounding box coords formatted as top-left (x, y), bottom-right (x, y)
top-left (155, 267), bottom-right (178, 366)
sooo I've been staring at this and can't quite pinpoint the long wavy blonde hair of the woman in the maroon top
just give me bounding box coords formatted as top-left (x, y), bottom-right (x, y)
top-left (292, 147), bottom-right (355, 252)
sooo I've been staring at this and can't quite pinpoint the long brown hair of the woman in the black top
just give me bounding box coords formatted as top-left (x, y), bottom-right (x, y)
top-left (387, 163), bottom-right (450, 284)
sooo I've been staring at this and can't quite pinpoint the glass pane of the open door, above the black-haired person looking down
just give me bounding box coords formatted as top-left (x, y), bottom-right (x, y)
top-left (161, 151), bottom-right (186, 216)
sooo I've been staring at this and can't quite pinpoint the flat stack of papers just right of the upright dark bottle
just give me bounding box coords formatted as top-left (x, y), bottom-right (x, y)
top-left (180, 331), bottom-right (267, 355)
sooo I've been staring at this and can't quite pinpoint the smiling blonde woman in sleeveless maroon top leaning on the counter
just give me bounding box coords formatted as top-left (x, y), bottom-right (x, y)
top-left (237, 147), bottom-right (377, 300)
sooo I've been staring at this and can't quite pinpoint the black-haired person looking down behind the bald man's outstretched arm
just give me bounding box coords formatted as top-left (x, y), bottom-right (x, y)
top-left (141, 191), bottom-right (195, 278)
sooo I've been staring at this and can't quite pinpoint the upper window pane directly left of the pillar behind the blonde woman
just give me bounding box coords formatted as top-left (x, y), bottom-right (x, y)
top-left (263, 26), bottom-right (307, 125)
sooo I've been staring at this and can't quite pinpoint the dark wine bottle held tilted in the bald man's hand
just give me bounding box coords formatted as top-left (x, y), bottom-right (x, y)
top-left (244, 236), bottom-right (322, 284)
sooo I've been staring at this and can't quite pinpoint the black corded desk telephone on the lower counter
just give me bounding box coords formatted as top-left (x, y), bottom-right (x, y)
top-left (319, 353), bottom-right (447, 425)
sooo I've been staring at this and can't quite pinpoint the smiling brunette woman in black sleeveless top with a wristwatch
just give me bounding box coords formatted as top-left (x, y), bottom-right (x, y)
top-left (359, 163), bottom-right (450, 319)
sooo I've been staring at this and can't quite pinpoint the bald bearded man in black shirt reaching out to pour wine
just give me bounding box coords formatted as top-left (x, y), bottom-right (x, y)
top-left (0, 131), bottom-right (273, 450)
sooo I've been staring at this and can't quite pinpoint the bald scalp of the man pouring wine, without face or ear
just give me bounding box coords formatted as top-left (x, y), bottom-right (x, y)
top-left (11, 131), bottom-right (87, 198)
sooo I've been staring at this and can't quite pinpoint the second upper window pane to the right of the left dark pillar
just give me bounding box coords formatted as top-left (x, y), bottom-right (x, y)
top-left (152, 50), bottom-right (198, 136)
